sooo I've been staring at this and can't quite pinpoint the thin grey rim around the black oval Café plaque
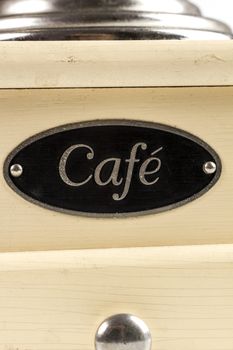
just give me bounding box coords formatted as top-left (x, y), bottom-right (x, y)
top-left (3, 119), bottom-right (222, 218)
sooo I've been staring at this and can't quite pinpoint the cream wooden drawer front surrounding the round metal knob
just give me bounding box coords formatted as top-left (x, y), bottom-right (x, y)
top-left (0, 245), bottom-right (233, 350)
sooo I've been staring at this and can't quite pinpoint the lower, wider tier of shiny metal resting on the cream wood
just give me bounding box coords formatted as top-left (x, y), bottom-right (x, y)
top-left (0, 11), bottom-right (232, 40)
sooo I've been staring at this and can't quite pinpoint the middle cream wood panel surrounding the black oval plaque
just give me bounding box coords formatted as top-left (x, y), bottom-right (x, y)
top-left (0, 87), bottom-right (233, 251)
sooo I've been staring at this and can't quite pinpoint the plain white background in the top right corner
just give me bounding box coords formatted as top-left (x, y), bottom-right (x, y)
top-left (192, 0), bottom-right (233, 30)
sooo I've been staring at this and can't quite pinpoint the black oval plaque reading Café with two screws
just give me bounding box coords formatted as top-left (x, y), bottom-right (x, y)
top-left (4, 120), bottom-right (221, 217)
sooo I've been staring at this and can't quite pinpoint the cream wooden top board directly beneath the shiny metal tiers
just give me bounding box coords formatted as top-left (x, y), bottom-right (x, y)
top-left (0, 40), bottom-right (233, 88)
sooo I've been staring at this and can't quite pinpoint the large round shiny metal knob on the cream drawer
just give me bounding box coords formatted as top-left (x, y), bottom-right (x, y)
top-left (95, 314), bottom-right (152, 350)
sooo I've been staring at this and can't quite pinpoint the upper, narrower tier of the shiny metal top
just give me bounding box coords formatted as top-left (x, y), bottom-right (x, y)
top-left (0, 0), bottom-right (201, 16)
